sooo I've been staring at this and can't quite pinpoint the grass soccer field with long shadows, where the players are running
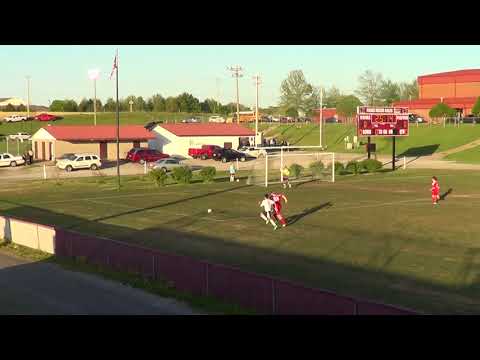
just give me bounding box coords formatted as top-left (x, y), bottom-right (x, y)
top-left (0, 170), bottom-right (480, 314)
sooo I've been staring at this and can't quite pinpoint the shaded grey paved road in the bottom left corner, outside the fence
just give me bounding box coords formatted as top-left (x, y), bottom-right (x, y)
top-left (0, 251), bottom-right (202, 315)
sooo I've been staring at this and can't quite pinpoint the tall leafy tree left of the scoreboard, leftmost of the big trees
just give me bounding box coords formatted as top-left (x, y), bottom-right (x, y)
top-left (280, 70), bottom-right (318, 113)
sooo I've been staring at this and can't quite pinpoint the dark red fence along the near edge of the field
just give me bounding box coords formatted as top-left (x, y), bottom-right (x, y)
top-left (55, 228), bottom-right (415, 315)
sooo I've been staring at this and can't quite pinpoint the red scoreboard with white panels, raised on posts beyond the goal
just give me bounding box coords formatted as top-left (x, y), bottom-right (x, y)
top-left (357, 106), bottom-right (408, 136)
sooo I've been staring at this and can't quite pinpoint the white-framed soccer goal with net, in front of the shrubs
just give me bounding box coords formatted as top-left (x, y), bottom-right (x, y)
top-left (247, 146), bottom-right (335, 187)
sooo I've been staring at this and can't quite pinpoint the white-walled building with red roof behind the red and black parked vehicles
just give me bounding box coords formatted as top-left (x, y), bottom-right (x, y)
top-left (152, 123), bottom-right (260, 157)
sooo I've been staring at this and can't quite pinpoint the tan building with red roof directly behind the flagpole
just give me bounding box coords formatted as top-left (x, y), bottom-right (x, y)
top-left (32, 125), bottom-right (155, 160)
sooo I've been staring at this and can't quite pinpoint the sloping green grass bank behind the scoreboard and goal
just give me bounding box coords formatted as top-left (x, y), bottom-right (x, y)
top-left (267, 124), bottom-right (480, 161)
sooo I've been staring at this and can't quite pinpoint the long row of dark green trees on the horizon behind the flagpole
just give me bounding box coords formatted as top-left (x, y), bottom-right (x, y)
top-left (49, 92), bottom-right (250, 115)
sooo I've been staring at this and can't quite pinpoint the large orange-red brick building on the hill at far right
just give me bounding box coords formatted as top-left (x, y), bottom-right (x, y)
top-left (393, 69), bottom-right (480, 120)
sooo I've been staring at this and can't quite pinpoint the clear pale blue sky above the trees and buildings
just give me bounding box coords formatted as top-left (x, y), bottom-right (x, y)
top-left (0, 45), bottom-right (480, 106)
